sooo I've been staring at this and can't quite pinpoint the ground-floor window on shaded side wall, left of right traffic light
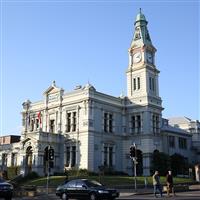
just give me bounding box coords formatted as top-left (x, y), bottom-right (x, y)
top-left (103, 144), bottom-right (114, 167)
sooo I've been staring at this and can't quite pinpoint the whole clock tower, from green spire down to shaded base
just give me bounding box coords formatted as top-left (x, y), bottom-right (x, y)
top-left (126, 9), bottom-right (163, 175)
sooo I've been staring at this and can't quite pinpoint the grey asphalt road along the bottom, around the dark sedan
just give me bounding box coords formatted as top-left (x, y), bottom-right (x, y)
top-left (10, 191), bottom-right (200, 200)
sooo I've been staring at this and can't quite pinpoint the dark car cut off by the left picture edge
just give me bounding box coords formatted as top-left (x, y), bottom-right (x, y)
top-left (0, 178), bottom-right (13, 200)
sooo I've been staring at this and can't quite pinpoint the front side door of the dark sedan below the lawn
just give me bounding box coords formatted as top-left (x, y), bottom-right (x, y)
top-left (76, 180), bottom-right (89, 199)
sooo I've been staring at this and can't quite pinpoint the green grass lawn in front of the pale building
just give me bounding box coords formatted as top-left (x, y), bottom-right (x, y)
top-left (24, 176), bottom-right (193, 187)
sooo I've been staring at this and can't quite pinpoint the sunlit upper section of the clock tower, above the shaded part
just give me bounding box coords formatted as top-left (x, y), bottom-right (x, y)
top-left (126, 9), bottom-right (162, 109)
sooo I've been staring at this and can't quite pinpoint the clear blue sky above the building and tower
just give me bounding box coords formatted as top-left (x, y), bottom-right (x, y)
top-left (0, 0), bottom-right (200, 135)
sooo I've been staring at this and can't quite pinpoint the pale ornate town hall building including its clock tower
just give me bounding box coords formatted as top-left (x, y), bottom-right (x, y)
top-left (0, 11), bottom-right (200, 175)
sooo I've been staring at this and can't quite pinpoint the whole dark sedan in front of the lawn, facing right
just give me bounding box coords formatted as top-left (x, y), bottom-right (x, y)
top-left (56, 179), bottom-right (119, 200)
